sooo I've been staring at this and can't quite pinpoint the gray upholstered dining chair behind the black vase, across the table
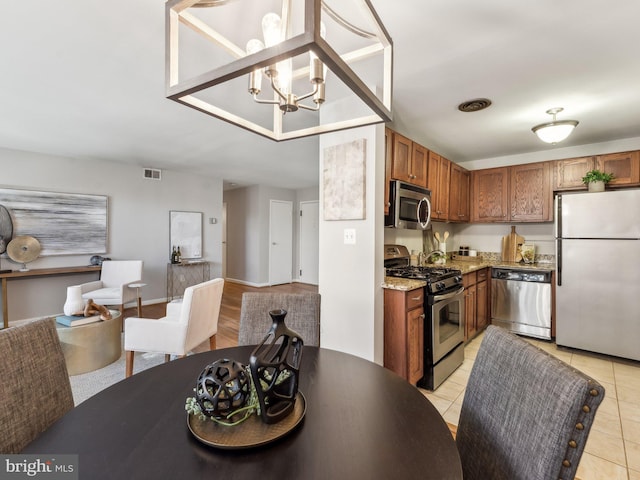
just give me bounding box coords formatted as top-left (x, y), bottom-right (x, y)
top-left (238, 292), bottom-right (320, 347)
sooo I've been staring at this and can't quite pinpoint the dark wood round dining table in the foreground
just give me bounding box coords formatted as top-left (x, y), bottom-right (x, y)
top-left (23, 346), bottom-right (462, 480)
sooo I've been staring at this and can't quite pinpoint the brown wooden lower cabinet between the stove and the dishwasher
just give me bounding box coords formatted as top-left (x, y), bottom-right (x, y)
top-left (462, 268), bottom-right (489, 341)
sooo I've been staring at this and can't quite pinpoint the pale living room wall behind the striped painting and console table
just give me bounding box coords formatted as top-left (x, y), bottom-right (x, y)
top-left (0, 149), bottom-right (222, 320)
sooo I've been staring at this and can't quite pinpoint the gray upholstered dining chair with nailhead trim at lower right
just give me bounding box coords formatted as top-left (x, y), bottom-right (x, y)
top-left (456, 326), bottom-right (604, 480)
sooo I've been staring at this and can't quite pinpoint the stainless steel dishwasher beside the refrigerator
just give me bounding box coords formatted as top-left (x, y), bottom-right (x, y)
top-left (491, 268), bottom-right (551, 340)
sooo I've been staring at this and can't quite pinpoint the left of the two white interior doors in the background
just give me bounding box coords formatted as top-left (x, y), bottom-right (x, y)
top-left (269, 200), bottom-right (293, 285)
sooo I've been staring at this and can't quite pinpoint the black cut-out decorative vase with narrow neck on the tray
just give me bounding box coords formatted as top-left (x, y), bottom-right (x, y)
top-left (249, 309), bottom-right (304, 424)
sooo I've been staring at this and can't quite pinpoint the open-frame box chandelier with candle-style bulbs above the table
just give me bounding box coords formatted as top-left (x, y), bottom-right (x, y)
top-left (166, 0), bottom-right (393, 141)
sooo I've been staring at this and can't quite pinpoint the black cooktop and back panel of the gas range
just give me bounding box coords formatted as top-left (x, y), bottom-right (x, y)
top-left (384, 245), bottom-right (462, 295)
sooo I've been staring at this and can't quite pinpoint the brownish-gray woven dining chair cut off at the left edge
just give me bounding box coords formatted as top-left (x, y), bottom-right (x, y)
top-left (0, 318), bottom-right (73, 454)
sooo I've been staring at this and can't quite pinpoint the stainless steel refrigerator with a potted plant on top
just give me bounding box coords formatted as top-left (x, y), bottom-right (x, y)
top-left (555, 189), bottom-right (640, 360)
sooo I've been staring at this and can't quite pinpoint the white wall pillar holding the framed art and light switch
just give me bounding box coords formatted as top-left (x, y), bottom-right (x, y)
top-left (319, 125), bottom-right (384, 364)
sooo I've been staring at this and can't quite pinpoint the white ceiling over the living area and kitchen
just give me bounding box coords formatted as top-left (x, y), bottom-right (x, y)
top-left (0, 0), bottom-right (640, 188)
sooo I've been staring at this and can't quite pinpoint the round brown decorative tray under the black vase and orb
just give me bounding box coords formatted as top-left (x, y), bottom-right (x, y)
top-left (187, 392), bottom-right (307, 450)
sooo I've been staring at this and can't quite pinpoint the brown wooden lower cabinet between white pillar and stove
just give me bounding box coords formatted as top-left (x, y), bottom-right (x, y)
top-left (384, 288), bottom-right (424, 385)
